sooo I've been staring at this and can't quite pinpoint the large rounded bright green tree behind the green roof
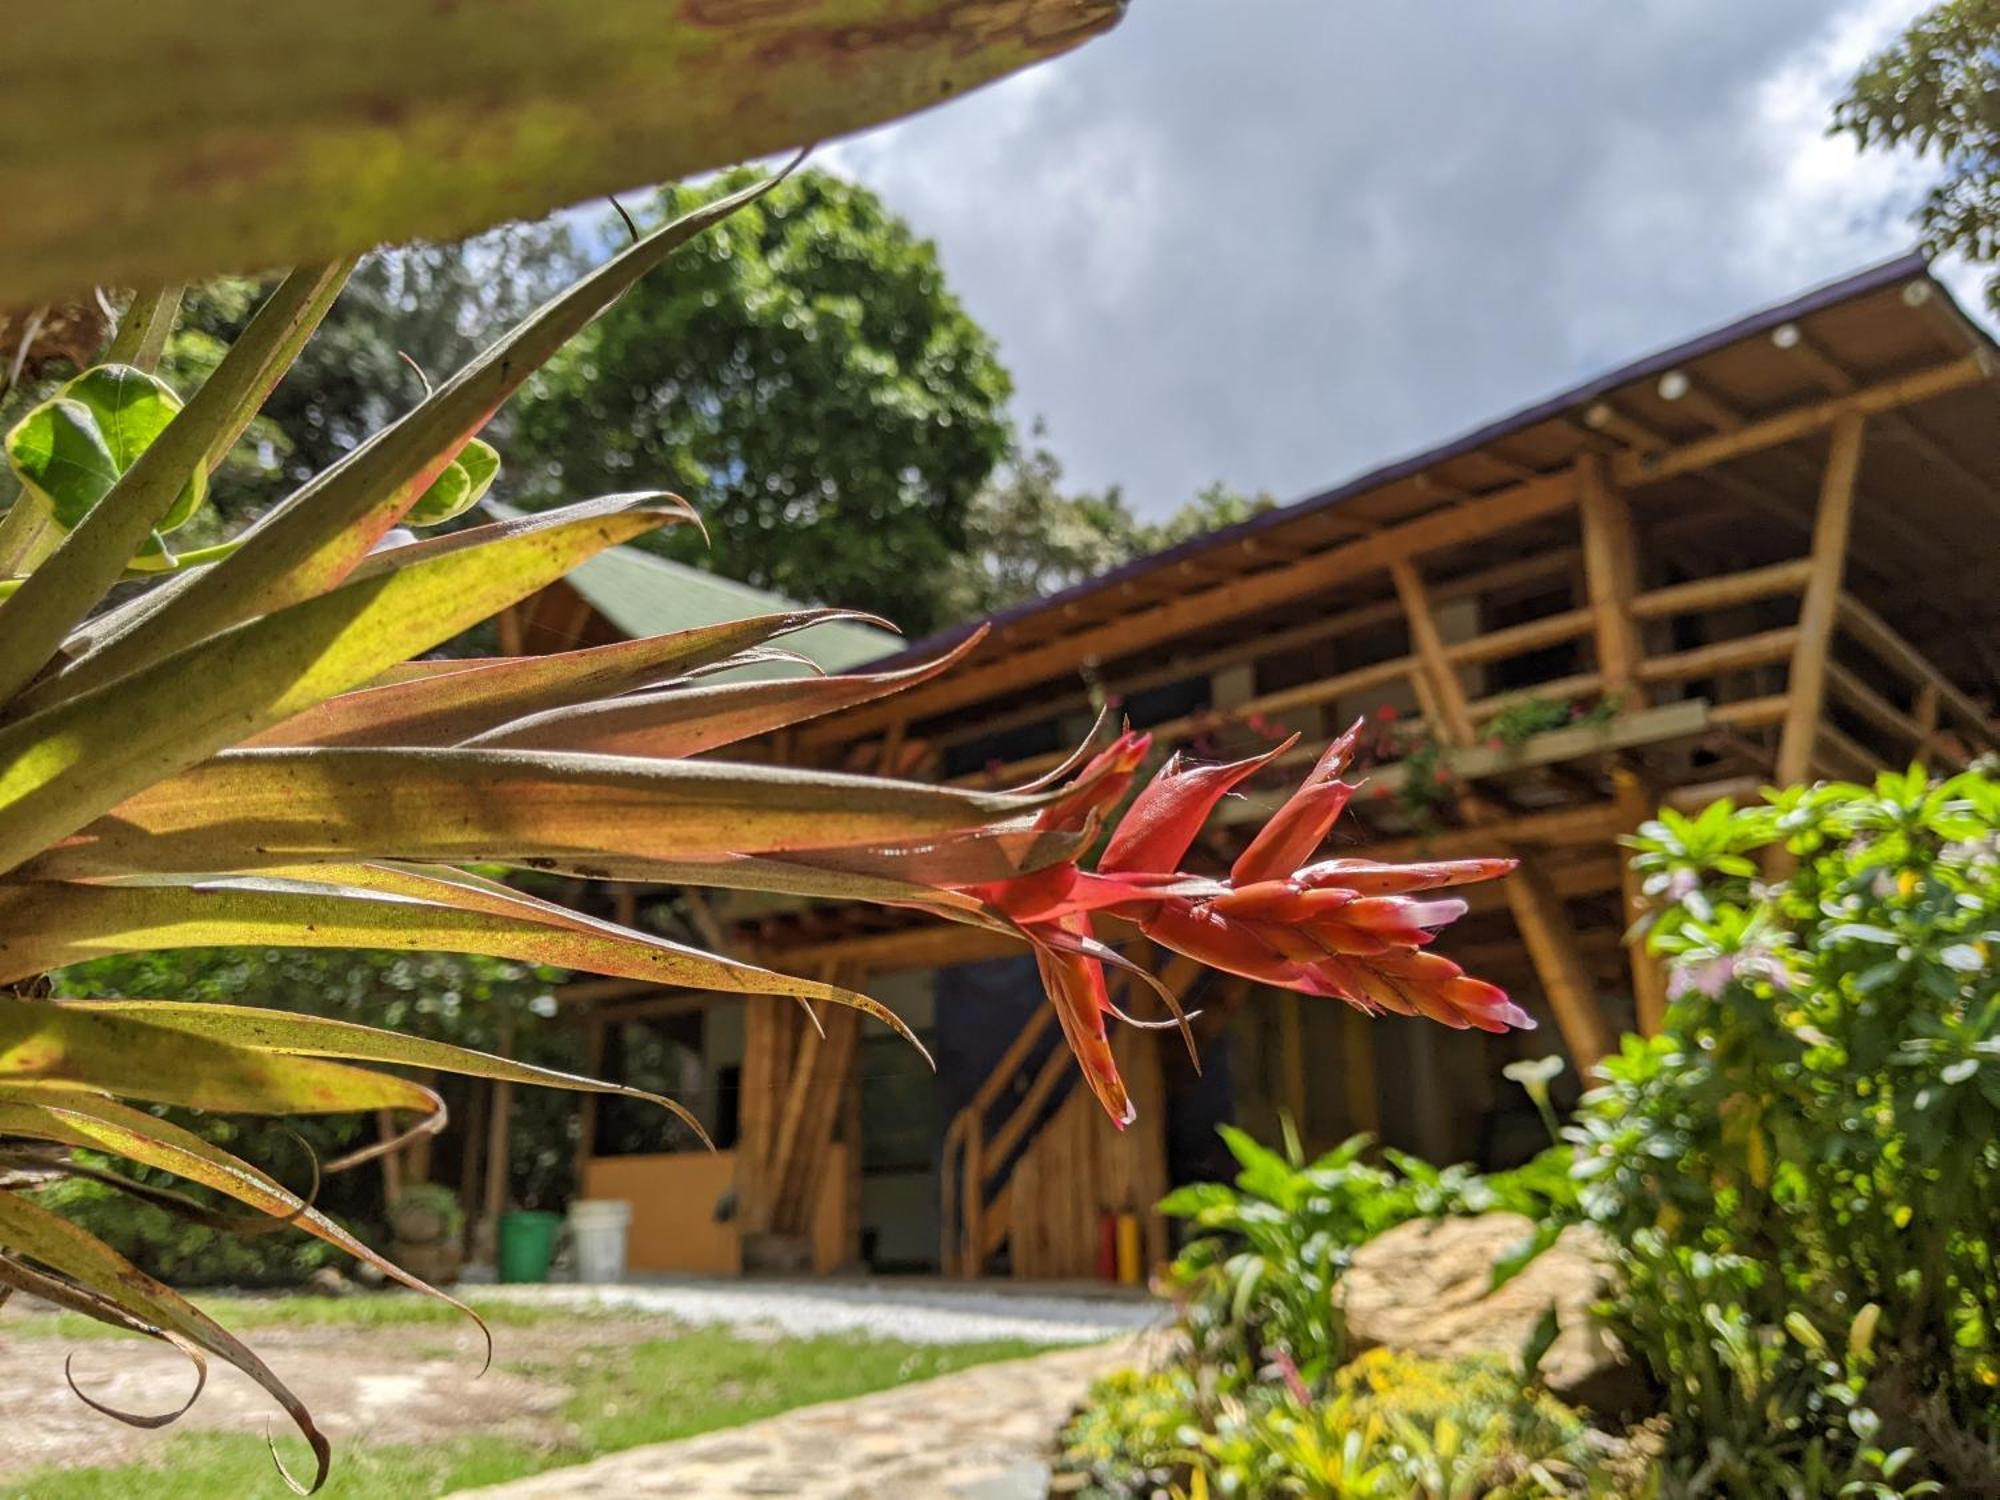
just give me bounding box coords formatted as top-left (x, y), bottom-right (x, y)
top-left (514, 172), bottom-right (1012, 630)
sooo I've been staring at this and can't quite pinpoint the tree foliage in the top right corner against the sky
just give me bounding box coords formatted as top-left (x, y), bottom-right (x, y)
top-left (1834, 0), bottom-right (2000, 312)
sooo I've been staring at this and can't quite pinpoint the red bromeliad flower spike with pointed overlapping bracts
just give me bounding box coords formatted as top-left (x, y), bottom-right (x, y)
top-left (960, 722), bottom-right (1534, 1126)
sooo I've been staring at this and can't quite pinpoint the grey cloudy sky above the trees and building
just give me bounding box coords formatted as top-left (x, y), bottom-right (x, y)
top-left (822, 0), bottom-right (1968, 514)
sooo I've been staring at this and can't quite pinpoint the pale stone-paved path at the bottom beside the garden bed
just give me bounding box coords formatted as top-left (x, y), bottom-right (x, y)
top-left (460, 1340), bottom-right (1136, 1500)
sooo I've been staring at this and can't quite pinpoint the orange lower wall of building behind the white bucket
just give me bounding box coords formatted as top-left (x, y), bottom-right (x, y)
top-left (584, 1144), bottom-right (848, 1276)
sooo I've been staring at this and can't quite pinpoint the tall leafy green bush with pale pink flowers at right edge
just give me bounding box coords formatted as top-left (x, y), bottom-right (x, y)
top-left (1544, 770), bottom-right (2000, 1496)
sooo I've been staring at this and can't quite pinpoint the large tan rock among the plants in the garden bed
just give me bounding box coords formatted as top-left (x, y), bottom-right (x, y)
top-left (1342, 1214), bottom-right (1652, 1414)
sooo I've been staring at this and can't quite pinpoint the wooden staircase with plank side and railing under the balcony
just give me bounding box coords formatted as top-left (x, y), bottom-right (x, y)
top-left (938, 956), bottom-right (1200, 1280)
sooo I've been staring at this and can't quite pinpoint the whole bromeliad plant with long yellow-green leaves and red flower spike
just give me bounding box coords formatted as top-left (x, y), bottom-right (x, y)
top-left (0, 186), bottom-right (1526, 1484)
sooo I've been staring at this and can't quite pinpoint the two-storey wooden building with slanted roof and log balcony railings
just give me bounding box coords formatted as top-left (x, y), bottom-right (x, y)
top-left (514, 258), bottom-right (2000, 1278)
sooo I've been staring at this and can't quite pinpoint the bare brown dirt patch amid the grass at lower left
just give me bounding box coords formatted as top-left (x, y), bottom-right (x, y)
top-left (0, 1320), bottom-right (648, 1476)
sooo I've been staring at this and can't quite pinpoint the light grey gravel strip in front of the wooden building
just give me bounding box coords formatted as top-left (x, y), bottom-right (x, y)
top-left (476, 1278), bottom-right (1166, 1344)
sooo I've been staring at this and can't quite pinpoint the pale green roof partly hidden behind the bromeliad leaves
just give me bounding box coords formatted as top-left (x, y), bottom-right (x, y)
top-left (568, 524), bottom-right (904, 676)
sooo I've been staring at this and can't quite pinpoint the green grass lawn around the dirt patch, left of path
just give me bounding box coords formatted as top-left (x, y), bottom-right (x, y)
top-left (0, 1298), bottom-right (1040, 1500)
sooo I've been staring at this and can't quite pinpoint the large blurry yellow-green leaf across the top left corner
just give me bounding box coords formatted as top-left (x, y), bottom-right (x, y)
top-left (0, 0), bottom-right (1122, 306)
